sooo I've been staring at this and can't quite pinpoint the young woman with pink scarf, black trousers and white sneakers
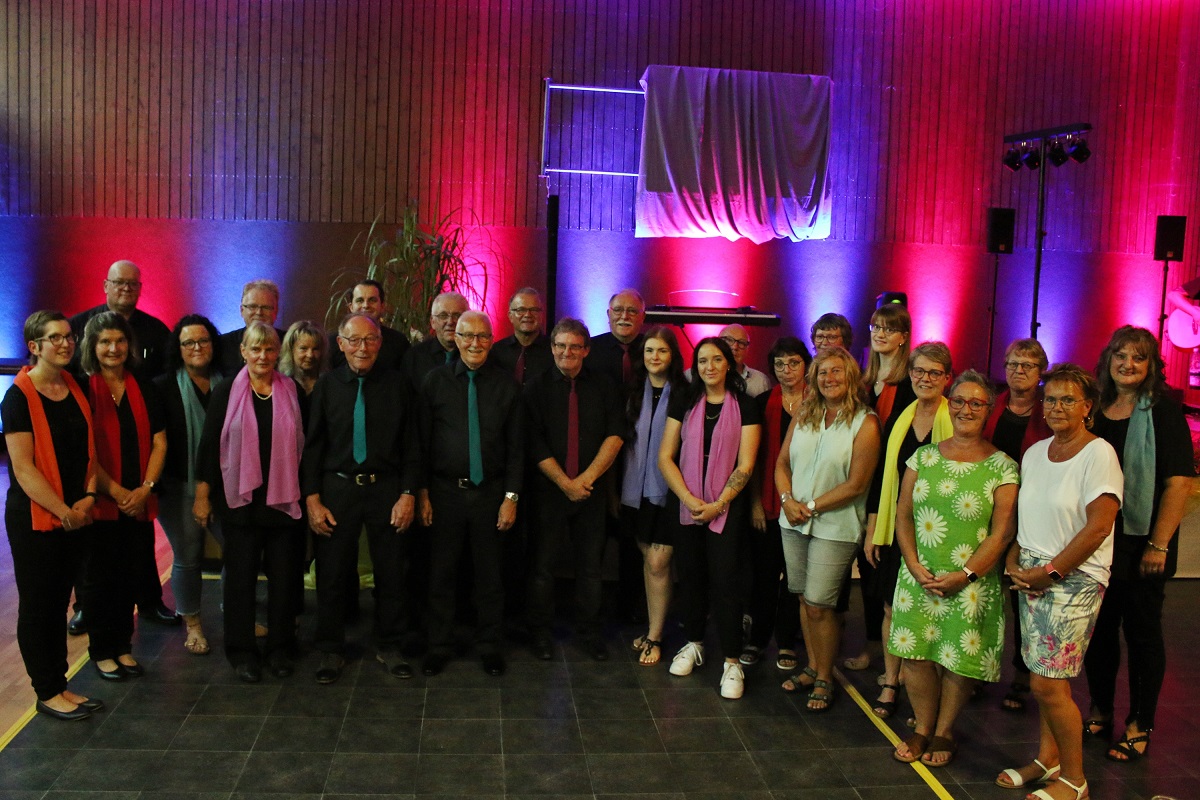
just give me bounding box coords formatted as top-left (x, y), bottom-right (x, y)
top-left (659, 337), bottom-right (762, 699)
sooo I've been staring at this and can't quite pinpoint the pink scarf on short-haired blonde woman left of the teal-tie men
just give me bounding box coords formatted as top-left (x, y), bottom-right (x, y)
top-left (221, 367), bottom-right (304, 519)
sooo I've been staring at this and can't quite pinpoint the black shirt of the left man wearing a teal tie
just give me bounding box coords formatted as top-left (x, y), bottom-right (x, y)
top-left (300, 365), bottom-right (420, 497)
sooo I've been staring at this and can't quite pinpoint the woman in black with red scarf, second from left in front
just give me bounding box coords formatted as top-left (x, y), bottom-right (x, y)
top-left (80, 311), bottom-right (167, 680)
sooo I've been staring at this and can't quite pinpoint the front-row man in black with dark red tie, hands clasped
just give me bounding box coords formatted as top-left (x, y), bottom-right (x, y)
top-left (524, 317), bottom-right (625, 661)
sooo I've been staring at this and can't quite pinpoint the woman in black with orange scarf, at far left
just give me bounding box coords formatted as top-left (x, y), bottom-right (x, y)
top-left (0, 311), bottom-right (104, 720)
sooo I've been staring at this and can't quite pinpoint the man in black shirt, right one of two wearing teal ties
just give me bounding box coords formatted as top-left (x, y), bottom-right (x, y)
top-left (420, 311), bottom-right (524, 675)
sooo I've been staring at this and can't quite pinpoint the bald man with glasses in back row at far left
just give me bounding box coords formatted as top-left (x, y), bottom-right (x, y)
top-left (70, 260), bottom-right (180, 636)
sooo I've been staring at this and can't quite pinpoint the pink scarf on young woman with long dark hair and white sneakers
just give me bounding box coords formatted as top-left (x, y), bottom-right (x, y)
top-left (676, 392), bottom-right (742, 534)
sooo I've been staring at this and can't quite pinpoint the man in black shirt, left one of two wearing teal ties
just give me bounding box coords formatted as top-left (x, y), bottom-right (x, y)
top-left (301, 314), bottom-right (420, 684)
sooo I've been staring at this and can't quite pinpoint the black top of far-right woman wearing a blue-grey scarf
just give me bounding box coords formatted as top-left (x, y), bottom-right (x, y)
top-left (1092, 397), bottom-right (1195, 579)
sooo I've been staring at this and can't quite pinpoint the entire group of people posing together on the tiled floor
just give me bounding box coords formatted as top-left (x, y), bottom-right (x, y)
top-left (2, 261), bottom-right (1193, 800)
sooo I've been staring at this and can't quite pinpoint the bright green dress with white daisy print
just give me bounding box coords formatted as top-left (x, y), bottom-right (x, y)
top-left (888, 444), bottom-right (1020, 681)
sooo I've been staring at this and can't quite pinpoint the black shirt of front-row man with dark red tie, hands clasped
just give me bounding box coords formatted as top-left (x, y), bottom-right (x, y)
top-left (524, 363), bottom-right (625, 493)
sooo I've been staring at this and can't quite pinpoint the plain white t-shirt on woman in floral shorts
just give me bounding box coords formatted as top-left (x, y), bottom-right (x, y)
top-left (1016, 438), bottom-right (1124, 587)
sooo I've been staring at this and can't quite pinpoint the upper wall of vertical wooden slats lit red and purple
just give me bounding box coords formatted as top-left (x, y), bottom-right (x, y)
top-left (0, 0), bottom-right (1200, 253)
